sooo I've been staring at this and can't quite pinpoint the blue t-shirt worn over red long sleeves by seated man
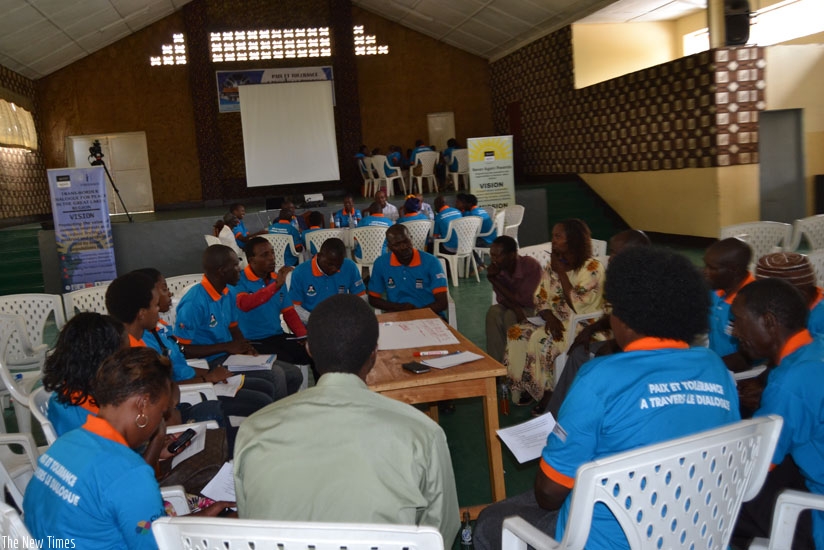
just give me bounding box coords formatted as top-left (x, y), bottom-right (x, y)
top-left (235, 265), bottom-right (294, 340)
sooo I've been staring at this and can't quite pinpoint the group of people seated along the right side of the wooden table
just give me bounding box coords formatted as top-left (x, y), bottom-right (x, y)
top-left (474, 219), bottom-right (824, 548)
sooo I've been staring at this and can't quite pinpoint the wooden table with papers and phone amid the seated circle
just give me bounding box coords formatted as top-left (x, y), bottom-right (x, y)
top-left (366, 309), bottom-right (506, 518)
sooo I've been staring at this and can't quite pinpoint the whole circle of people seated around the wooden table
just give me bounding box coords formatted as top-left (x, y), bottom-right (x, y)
top-left (19, 208), bottom-right (824, 549)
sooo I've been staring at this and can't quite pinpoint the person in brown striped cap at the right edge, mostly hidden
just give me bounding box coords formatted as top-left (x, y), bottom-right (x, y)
top-left (755, 252), bottom-right (824, 338)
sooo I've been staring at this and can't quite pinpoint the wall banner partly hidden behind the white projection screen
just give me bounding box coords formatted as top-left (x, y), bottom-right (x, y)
top-left (216, 66), bottom-right (335, 113)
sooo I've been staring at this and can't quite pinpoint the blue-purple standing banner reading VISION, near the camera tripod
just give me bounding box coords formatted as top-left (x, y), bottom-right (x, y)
top-left (47, 166), bottom-right (117, 292)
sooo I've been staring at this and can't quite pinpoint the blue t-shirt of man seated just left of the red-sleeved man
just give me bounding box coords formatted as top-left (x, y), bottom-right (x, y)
top-left (174, 276), bottom-right (238, 361)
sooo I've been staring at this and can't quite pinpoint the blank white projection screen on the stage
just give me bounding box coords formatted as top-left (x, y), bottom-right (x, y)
top-left (238, 80), bottom-right (340, 187)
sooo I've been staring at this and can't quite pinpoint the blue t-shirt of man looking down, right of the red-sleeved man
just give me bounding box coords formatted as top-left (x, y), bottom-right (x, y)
top-left (289, 256), bottom-right (366, 311)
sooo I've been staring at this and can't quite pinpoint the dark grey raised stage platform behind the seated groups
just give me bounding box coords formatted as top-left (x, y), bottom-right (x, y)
top-left (35, 187), bottom-right (550, 294)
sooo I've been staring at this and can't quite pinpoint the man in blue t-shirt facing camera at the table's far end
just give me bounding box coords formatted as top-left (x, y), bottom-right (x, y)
top-left (369, 224), bottom-right (449, 316)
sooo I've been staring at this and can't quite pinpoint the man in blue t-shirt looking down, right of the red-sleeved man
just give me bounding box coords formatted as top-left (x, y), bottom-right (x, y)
top-left (289, 238), bottom-right (366, 323)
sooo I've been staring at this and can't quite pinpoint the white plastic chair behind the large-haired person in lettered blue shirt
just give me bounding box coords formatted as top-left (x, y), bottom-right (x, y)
top-left (502, 415), bottom-right (783, 550)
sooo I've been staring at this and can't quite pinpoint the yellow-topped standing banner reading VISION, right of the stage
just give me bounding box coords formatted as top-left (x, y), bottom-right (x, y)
top-left (467, 136), bottom-right (515, 209)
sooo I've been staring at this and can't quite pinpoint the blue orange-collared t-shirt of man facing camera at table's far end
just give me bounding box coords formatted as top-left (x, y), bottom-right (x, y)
top-left (369, 250), bottom-right (447, 308)
